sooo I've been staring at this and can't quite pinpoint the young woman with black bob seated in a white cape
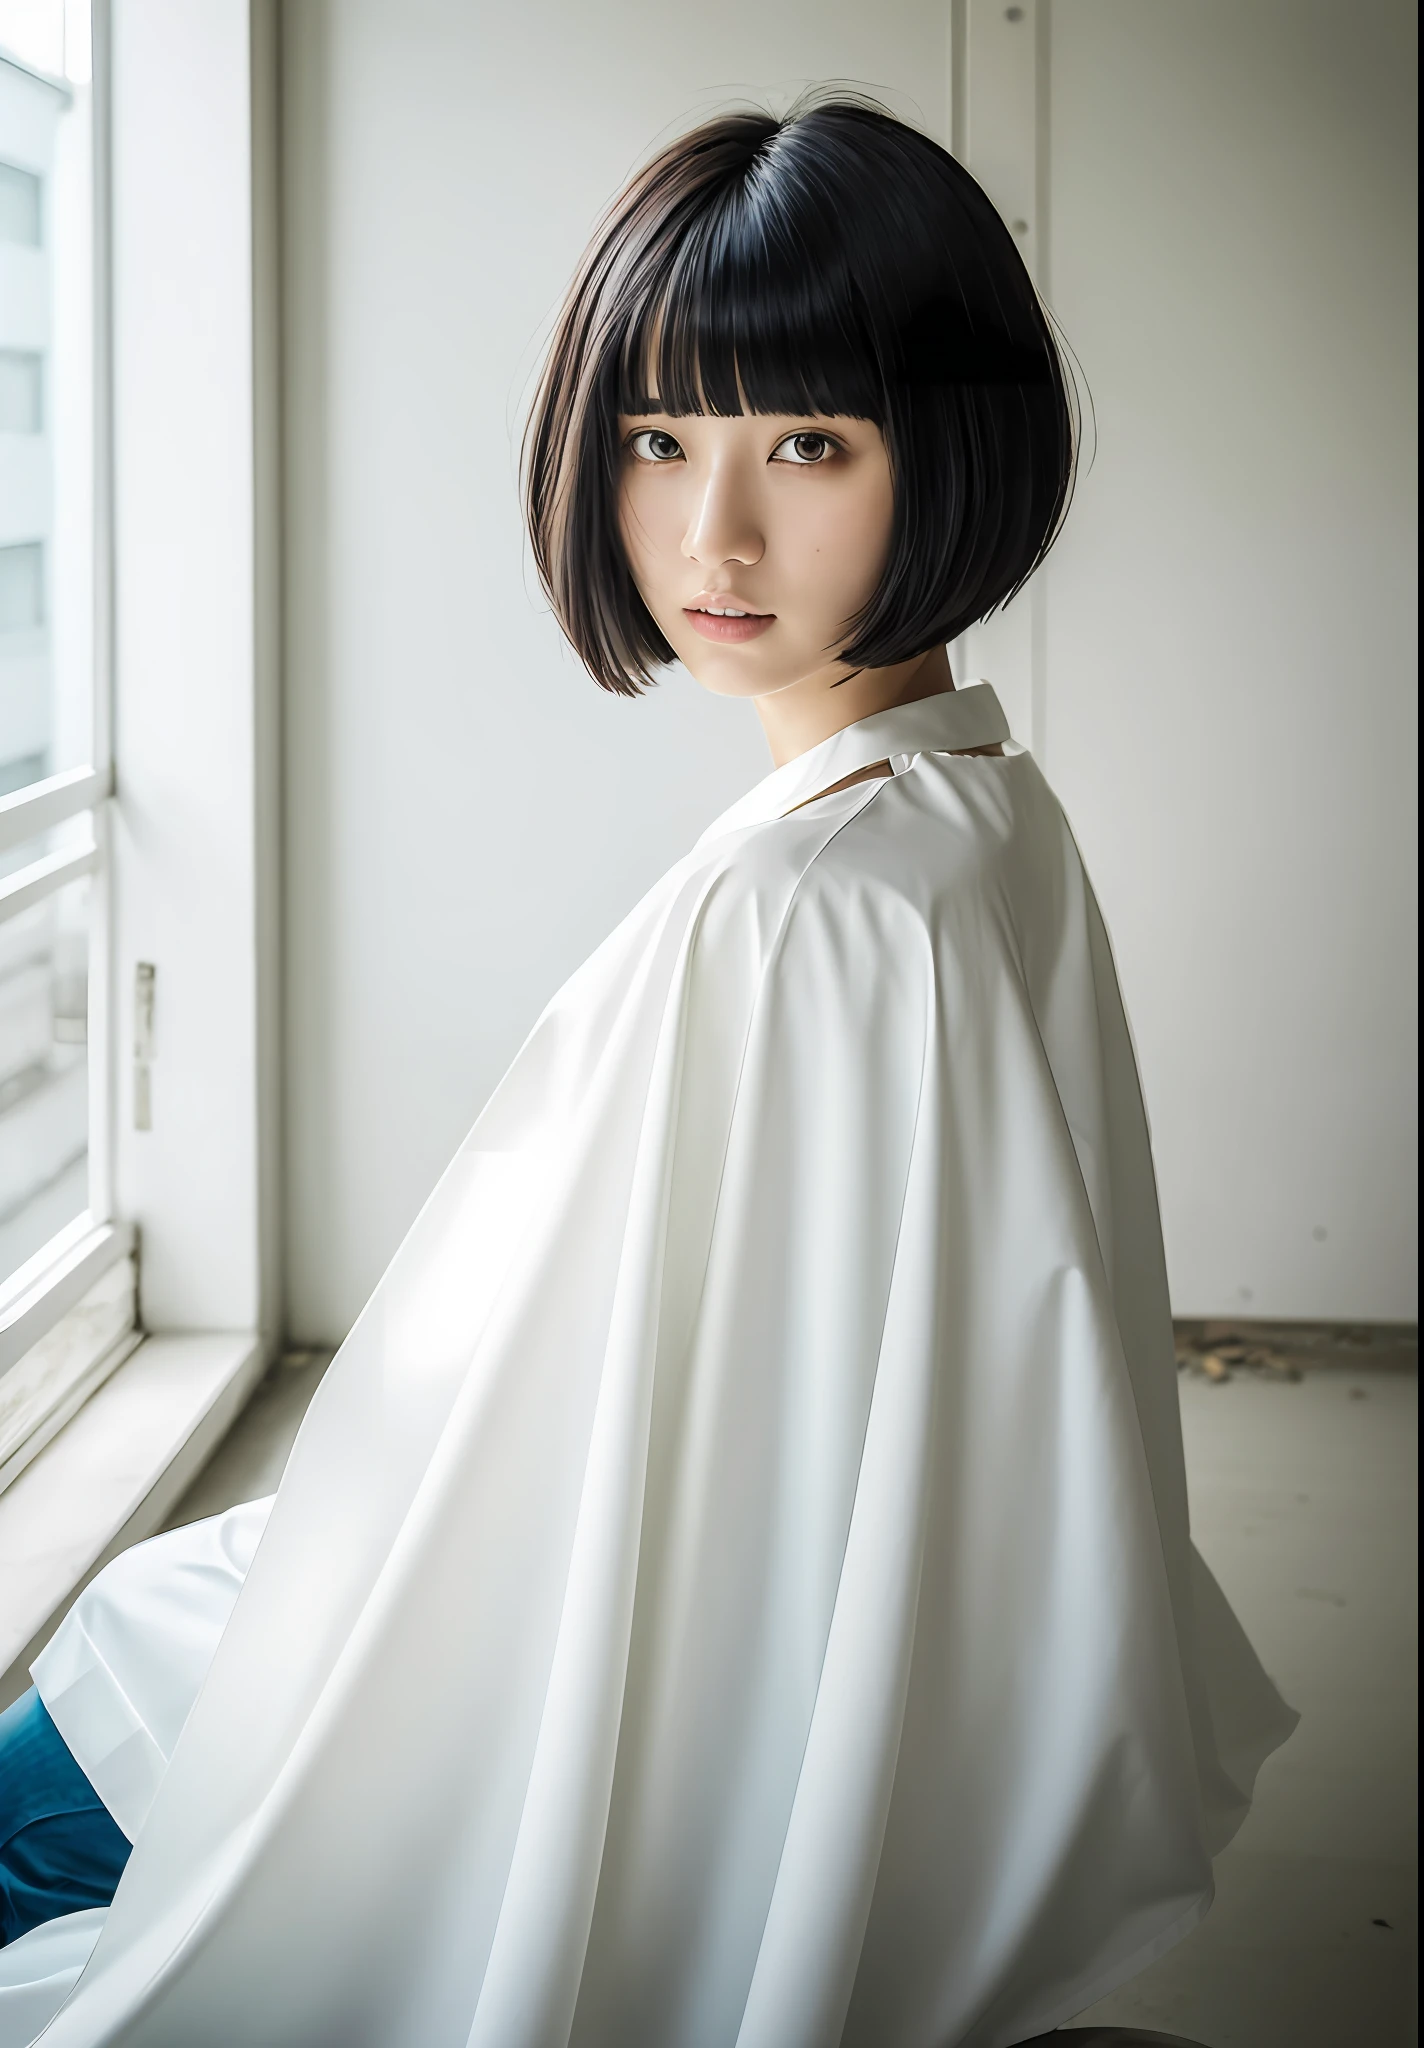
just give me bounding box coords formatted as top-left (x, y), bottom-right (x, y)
top-left (0, 100), bottom-right (1291, 2048)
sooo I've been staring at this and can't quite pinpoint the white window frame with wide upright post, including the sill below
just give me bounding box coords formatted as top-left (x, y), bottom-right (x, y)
top-left (0, 0), bottom-right (281, 1706)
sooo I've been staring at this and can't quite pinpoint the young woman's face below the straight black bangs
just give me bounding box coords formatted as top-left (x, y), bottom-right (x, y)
top-left (619, 412), bottom-right (893, 696)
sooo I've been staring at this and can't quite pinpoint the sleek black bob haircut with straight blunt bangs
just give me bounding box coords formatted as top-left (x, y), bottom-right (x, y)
top-left (525, 94), bottom-right (1078, 696)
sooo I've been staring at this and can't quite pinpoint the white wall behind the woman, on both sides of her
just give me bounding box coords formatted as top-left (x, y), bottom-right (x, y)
top-left (283, 0), bottom-right (1412, 1339)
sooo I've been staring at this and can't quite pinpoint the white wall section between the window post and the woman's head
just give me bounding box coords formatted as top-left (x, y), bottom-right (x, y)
top-left (285, 0), bottom-right (947, 1339)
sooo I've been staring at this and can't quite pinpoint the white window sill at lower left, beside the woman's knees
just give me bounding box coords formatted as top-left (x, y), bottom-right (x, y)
top-left (0, 1331), bottom-right (266, 1708)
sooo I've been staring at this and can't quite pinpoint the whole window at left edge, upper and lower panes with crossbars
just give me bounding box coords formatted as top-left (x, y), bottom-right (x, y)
top-left (0, 0), bottom-right (135, 1489)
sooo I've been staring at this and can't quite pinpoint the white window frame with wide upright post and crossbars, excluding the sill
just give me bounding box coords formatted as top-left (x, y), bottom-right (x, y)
top-left (0, 0), bottom-right (279, 1358)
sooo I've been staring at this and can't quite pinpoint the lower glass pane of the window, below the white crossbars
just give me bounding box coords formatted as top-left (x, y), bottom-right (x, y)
top-left (0, 860), bottom-right (92, 1280)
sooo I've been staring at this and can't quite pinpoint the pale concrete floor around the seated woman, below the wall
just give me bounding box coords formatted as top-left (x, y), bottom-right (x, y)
top-left (170, 1358), bottom-right (1418, 2048)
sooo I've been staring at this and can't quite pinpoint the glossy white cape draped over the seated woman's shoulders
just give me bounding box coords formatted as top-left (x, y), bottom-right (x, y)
top-left (27, 686), bottom-right (1293, 2048)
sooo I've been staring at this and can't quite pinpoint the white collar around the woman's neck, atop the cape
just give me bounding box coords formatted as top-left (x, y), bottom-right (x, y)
top-left (697, 682), bottom-right (1010, 846)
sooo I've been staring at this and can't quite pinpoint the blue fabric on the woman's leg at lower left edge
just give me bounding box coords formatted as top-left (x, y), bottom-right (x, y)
top-left (0, 1686), bottom-right (129, 1948)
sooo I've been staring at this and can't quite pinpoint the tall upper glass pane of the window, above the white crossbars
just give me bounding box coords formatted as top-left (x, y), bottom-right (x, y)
top-left (0, 12), bottom-right (94, 795)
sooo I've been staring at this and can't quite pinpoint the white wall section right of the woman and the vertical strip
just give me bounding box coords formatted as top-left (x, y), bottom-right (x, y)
top-left (1035, 0), bottom-right (1418, 1319)
